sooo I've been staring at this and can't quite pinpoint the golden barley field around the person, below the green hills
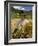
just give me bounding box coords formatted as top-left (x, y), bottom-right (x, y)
top-left (11, 18), bottom-right (32, 38)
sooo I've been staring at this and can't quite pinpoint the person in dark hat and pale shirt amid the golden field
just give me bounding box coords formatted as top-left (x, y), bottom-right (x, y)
top-left (13, 11), bottom-right (29, 38)
